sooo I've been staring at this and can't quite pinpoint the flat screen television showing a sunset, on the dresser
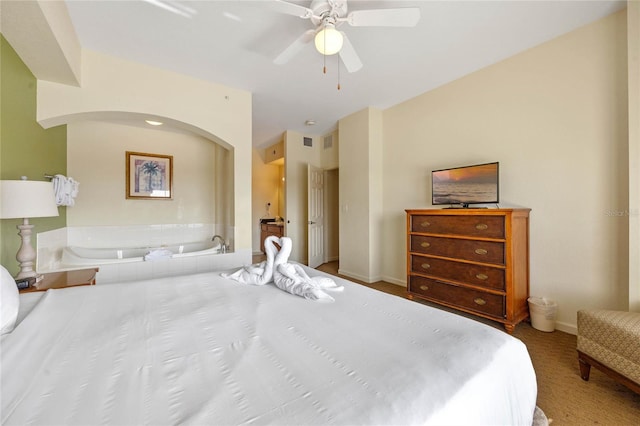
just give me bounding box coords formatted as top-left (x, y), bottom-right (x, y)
top-left (431, 162), bottom-right (500, 208)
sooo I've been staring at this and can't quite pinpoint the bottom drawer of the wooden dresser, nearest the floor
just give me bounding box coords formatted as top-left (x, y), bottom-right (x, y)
top-left (409, 276), bottom-right (505, 319)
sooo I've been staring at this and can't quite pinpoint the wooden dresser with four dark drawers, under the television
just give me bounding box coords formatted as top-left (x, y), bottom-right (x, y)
top-left (406, 209), bottom-right (530, 333)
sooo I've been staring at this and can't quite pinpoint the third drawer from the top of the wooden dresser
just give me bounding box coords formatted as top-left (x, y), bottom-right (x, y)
top-left (411, 255), bottom-right (505, 290)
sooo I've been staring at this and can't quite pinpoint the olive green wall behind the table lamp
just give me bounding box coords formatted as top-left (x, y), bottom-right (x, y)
top-left (0, 35), bottom-right (67, 275)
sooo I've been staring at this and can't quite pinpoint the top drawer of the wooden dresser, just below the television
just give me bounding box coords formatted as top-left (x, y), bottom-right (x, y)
top-left (411, 215), bottom-right (505, 238)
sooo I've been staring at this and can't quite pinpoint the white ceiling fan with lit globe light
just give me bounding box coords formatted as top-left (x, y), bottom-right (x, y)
top-left (273, 0), bottom-right (420, 72)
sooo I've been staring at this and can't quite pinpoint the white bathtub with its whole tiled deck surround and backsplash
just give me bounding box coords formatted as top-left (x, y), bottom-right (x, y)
top-left (38, 224), bottom-right (251, 284)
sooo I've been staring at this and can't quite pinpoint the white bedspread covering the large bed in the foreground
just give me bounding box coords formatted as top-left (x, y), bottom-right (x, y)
top-left (1, 270), bottom-right (536, 425)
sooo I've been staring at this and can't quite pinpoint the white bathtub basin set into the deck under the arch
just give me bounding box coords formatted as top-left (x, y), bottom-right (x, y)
top-left (62, 241), bottom-right (222, 266)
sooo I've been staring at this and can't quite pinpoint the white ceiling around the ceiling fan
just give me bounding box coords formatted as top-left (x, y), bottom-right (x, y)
top-left (67, 0), bottom-right (626, 147)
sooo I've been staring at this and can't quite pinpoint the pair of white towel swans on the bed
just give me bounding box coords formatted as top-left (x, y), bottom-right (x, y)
top-left (221, 236), bottom-right (344, 303)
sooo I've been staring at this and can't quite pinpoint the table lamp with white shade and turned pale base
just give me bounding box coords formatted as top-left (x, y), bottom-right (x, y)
top-left (0, 176), bottom-right (58, 279)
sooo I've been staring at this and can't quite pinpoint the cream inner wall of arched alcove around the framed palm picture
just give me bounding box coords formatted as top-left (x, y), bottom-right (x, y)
top-left (33, 112), bottom-right (242, 274)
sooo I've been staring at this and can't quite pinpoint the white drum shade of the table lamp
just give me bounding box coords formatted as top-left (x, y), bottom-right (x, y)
top-left (0, 180), bottom-right (58, 219)
